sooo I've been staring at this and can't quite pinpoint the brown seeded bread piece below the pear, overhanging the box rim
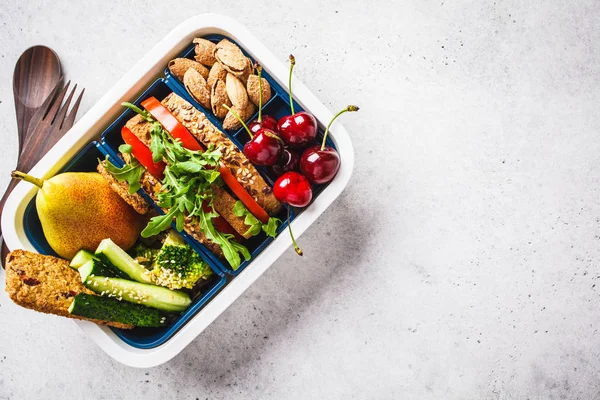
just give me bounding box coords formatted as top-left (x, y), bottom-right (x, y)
top-left (4, 250), bottom-right (134, 329)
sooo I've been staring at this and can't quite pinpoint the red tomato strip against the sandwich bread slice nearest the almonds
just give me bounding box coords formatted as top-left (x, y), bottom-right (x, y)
top-left (142, 97), bottom-right (269, 224)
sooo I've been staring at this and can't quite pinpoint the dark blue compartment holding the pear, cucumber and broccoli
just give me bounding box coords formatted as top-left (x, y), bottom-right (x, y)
top-left (23, 142), bottom-right (226, 349)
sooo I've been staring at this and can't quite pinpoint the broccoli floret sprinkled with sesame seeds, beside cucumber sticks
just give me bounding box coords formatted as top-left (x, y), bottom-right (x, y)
top-left (151, 233), bottom-right (212, 289)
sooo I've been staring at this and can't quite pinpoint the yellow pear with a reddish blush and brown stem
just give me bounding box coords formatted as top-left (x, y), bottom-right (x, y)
top-left (12, 171), bottom-right (143, 259)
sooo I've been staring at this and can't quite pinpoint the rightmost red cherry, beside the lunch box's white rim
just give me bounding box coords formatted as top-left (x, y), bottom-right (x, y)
top-left (300, 146), bottom-right (340, 183)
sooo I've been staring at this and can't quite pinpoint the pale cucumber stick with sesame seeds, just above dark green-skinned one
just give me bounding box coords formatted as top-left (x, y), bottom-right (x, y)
top-left (83, 276), bottom-right (192, 312)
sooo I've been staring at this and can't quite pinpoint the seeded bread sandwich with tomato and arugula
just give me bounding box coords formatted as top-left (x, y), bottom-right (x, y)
top-left (98, 93), bottom-right (282, 270)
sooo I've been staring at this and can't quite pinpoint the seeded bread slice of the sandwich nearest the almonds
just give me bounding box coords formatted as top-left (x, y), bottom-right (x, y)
top-left (162, 93), bottom-right (282, 216)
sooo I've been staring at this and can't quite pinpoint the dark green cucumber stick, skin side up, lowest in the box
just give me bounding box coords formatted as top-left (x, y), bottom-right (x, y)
top-left (69, 293), bottom-right (167, 327)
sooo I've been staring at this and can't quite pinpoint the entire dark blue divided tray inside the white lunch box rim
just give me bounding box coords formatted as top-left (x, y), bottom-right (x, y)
top-left (24, 35), bottom-right (335, 349)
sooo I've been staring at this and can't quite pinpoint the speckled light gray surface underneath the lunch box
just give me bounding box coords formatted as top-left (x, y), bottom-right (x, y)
top-left (0, 0), bottom-right (600, 400)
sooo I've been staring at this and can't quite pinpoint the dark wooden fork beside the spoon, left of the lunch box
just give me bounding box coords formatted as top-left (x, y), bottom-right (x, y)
top-left (0, 79), bottom-right (85, 264)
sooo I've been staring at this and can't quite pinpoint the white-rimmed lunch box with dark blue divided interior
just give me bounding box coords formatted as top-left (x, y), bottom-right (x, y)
top-left (1, 14), bottom-right (354, 367)
